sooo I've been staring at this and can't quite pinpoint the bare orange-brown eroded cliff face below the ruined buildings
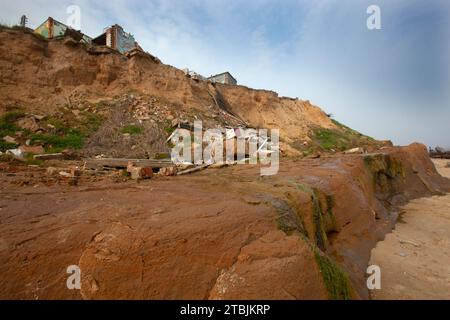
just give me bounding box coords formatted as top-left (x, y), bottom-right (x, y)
top-left (0, 28), bottom-right (352, 158)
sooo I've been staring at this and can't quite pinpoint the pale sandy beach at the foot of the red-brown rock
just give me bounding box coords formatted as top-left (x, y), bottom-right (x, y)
top-left (370, 160), bottom-right (450, 299)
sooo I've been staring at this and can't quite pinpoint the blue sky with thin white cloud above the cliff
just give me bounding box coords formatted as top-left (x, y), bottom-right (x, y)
top-left (0, 0), bottom-right (450, 148)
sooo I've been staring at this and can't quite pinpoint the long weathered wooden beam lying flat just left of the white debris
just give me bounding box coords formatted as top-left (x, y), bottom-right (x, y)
top-left (84, 158), bottom-right (174, 169)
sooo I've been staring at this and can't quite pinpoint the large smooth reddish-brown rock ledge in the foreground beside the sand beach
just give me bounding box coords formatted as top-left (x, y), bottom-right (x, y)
top-left (0, 145), bottom-right (449, 299)
